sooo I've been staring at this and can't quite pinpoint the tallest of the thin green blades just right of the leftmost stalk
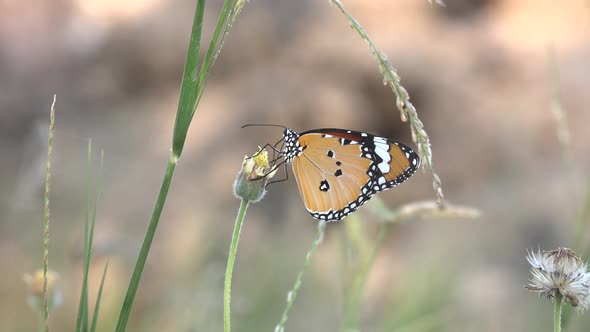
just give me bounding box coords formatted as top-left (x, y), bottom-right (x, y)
top-left (76, 139), bottom-right (92, 332)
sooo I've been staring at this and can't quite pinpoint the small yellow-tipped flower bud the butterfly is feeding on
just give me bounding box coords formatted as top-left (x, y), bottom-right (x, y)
top-left (234, 150), bottom-right (277, 202)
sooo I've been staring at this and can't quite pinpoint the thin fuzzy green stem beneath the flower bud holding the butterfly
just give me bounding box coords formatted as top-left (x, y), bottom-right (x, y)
top-left (223, 199), bottom-right (249, 332)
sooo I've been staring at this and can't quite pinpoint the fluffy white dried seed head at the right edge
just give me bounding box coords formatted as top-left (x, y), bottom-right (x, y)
top-left (525, 247), bottom-right (590, 311)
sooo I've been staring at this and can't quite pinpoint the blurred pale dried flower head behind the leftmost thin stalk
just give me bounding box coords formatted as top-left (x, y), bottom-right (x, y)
top-left (23, 270), bottom-right (62, 312)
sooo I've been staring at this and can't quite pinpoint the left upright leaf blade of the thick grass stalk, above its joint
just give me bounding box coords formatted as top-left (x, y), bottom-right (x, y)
top-left (172, 0), bottom-right (205, 157)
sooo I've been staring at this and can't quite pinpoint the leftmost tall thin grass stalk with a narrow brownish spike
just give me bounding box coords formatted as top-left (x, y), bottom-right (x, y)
top-left (43, 95), bottom-right (57, 332)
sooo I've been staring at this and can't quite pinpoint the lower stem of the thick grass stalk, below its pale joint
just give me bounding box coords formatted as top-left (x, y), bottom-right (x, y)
top-left (115, 156), bottom-right (178, 332)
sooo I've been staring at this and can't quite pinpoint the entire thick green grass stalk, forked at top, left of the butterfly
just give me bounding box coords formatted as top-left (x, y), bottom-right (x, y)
top-left (116, 0), bottom-right (249, 332)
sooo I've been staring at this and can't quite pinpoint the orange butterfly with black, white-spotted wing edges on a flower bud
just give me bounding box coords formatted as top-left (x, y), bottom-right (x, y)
top-left (252, 126), bottom-right (420, 221)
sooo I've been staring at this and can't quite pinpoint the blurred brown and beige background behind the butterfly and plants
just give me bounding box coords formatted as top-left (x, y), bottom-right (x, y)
top-left (0, 0), bottom-right (590, 331)
